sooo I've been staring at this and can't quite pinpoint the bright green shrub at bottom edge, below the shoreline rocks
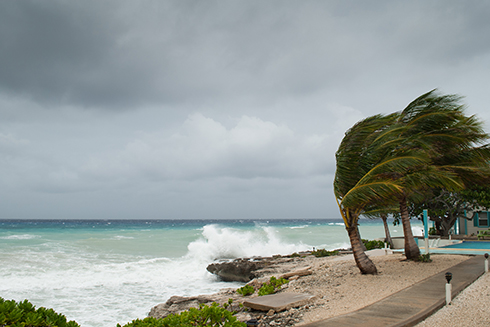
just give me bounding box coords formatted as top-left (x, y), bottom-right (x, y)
top-left (117, 301), bottom-right (247, 327)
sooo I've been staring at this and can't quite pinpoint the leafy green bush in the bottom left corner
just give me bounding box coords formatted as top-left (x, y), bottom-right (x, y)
top-left (0, 297), bottom-right (80, 327)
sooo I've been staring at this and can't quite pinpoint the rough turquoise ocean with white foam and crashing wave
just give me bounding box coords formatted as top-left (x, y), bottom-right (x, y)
top-left (0, 219), bottom-right (421, 327)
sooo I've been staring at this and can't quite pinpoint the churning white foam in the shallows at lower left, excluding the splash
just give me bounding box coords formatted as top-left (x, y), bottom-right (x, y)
top-left (0, 245), bottom-right (236, 327)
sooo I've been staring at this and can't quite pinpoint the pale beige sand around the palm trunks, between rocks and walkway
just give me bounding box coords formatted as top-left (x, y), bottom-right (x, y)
top-left (251, 254), bottom-right (468, 326)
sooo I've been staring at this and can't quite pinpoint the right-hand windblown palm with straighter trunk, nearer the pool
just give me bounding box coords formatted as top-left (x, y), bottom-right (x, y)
top-left (398, 90), bottom-right (490, 259)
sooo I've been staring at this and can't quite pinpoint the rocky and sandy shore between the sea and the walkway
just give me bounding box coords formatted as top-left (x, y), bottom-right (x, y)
top-left (149, 250), bottom-right (467, 327)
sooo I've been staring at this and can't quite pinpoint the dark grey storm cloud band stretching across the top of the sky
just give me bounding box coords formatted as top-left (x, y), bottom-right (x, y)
top-left (0, 1), bottom-right (490, 107)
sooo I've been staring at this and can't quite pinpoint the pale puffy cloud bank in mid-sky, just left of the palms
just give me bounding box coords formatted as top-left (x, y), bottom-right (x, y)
top-left (84, 114), bottom-right (333, 181)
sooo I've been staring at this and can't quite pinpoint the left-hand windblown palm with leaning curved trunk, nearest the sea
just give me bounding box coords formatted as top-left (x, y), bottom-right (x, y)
top-left (334, 114), bottom-right (425, 274)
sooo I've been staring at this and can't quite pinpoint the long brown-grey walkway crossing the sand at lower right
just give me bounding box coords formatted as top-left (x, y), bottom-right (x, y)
top-left (302, 256), bottom-right (485, 327)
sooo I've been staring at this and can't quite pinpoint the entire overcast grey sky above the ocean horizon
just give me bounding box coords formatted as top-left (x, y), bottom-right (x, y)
top-left (0, 0), bottom-right (490, 219)
